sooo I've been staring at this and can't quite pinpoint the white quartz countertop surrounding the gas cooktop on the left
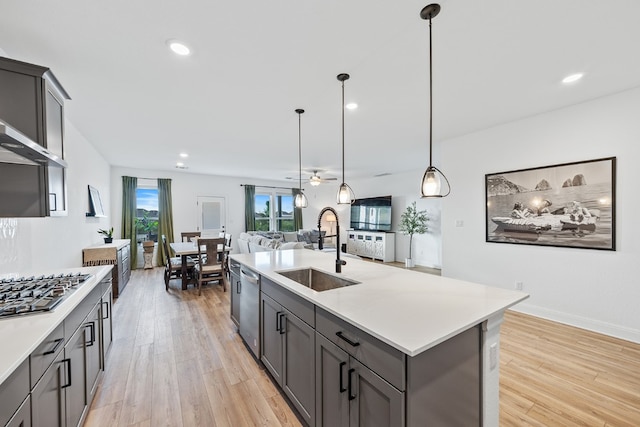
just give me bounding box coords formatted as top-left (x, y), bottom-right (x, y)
top-left (0, 266), bottom-right (112, 384)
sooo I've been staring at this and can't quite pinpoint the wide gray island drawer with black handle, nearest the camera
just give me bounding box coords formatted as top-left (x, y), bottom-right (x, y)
top-left (316, 307), bottom-right (406, 391)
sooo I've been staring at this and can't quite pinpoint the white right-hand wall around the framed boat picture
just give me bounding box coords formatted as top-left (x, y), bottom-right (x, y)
top-left (442, 88), bottom-right (640, 342)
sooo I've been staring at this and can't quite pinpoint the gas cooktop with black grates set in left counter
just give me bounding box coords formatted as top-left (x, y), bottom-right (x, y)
top-left (0, 273), bottom-right (91, 319)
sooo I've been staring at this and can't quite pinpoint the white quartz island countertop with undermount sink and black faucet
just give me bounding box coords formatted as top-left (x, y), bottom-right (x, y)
top-left (231, 249), bottom-right (529, 356)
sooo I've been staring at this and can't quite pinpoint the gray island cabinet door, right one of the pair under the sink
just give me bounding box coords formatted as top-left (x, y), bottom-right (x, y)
top-left (281, 310), bottom-right (315, 426)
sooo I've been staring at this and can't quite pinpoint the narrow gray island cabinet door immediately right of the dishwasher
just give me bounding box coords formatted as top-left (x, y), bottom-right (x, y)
top-left (260, 293), bottom-right (284, 387)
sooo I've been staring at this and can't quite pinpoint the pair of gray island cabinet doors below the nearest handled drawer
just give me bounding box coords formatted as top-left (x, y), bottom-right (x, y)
top-left (315, 333), bottom-right (404, 427)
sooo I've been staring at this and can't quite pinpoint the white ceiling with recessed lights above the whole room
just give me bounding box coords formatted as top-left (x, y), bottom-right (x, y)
top-left (0, 0), bottom-right (640, 181)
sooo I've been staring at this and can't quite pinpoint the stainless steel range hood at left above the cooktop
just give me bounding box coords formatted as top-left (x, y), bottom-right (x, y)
top-left (0, 119), bottom-right (67, 168)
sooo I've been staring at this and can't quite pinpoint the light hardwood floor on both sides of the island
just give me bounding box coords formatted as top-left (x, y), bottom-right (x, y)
top-left (85, 268), bottom-right (640, 427)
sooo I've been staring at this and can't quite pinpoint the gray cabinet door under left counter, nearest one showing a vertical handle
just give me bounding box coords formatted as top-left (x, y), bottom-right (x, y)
top-left (31, 351), bottom-right (69, 427)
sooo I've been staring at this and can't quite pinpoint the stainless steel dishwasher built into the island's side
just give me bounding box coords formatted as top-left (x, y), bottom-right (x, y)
top-left (239, 266), bottom-right (260, 359)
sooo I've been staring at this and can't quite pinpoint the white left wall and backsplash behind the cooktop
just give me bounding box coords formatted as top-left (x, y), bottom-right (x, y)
top-left (0, 121), bottom-right (110, 275)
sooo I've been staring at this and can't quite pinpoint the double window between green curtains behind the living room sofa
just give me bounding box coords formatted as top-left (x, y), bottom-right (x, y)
top-left (255, 191), bottom-right (296, 231)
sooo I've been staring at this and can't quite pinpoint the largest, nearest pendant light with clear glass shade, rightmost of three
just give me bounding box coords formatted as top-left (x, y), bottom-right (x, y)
top-left (420, 3), bottom-right (451, 198)
